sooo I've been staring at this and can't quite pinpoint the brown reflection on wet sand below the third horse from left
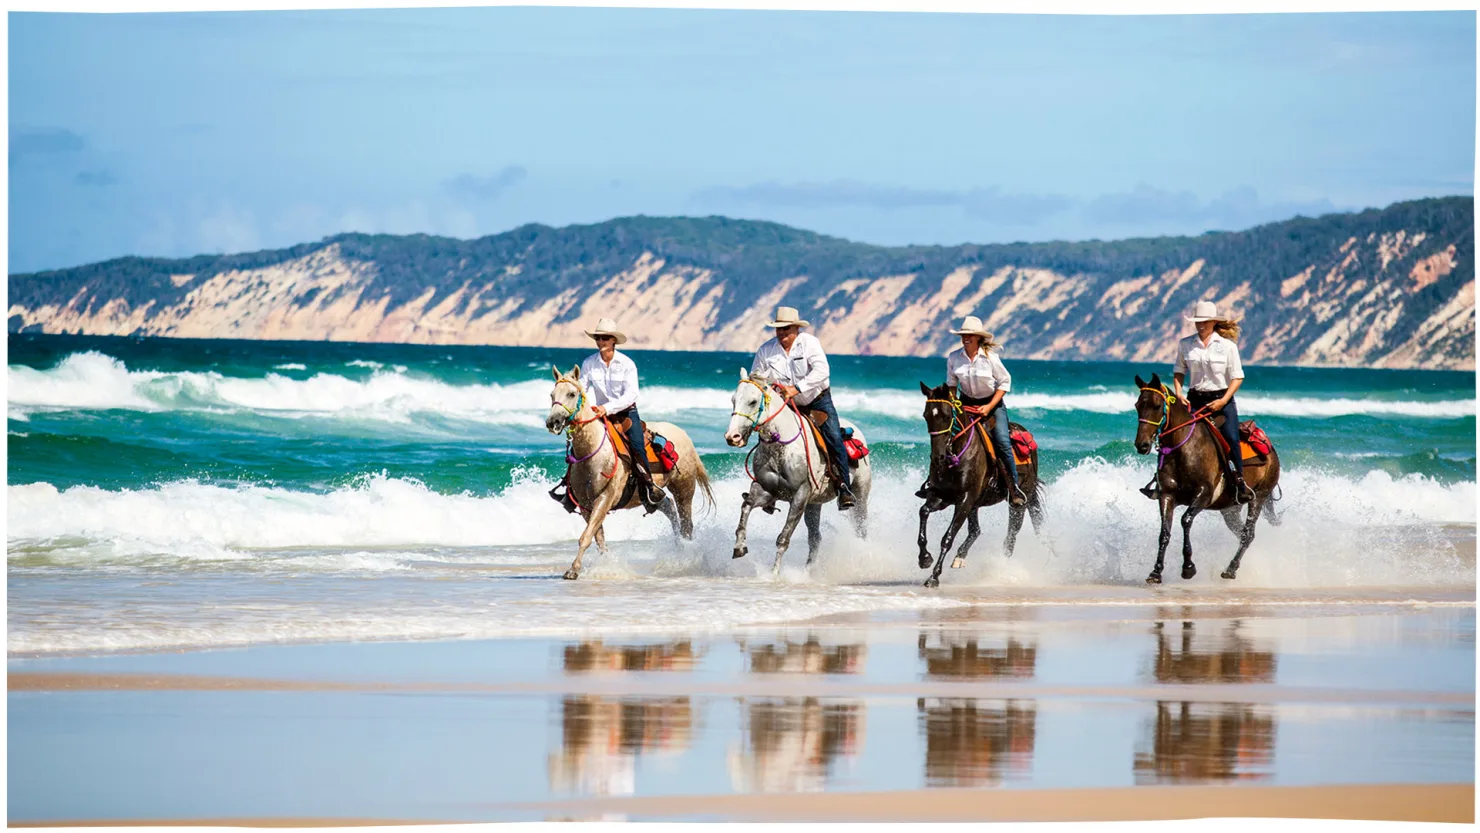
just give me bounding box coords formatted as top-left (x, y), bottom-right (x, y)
top-left (916, 632), bottom-right (1037, 787)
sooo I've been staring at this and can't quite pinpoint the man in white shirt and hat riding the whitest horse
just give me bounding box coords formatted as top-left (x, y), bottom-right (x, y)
top-left (750, 306), bottom-right (855, 510)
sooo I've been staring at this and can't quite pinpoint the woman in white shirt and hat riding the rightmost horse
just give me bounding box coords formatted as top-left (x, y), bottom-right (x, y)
top-left (1172, 300), bottom-right (1254, 503)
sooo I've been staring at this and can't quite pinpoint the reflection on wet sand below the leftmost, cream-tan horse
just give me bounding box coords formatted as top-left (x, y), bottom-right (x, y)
top-left (549, 639), bottom-right (702, 796)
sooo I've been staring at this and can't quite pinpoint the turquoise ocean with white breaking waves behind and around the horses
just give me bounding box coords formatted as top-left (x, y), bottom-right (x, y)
top-left (6, 334), bottom-right (1476, 655)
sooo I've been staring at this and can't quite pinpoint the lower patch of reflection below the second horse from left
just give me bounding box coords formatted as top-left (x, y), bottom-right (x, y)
top-left (730, 697), bottom-right (864, 793)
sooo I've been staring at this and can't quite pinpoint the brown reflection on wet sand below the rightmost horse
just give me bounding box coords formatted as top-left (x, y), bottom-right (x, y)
top-left (1134, 618), bottom-right (1276, 784)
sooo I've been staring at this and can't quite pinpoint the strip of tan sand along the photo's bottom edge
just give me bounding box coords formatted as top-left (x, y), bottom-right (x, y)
top-left (10, 784), bottom-right (1476, 827)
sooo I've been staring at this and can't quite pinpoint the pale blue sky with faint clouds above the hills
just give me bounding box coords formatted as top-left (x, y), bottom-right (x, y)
top-left (9, 7), bottom-right (1476, 272)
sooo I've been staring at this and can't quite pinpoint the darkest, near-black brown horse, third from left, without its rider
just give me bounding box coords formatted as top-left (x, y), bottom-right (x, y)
top-left (919, 382), bottom-right (1043, 587)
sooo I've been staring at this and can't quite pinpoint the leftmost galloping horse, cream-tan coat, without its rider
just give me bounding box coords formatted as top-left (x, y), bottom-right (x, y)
top-left (545, 367), bottom-right (715, 579)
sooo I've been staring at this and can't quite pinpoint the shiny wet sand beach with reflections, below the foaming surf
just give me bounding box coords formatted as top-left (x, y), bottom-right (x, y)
top-left (9, 589), bottom-right (1476, 826)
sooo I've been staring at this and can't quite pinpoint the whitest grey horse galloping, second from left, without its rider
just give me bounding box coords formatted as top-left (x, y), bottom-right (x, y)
top-left (725, 368), bottom-right (873, 574)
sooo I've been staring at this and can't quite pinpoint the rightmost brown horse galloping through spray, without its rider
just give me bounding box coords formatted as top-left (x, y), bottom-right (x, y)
top-left (1135, 373), bottom-right (1280, 584)
